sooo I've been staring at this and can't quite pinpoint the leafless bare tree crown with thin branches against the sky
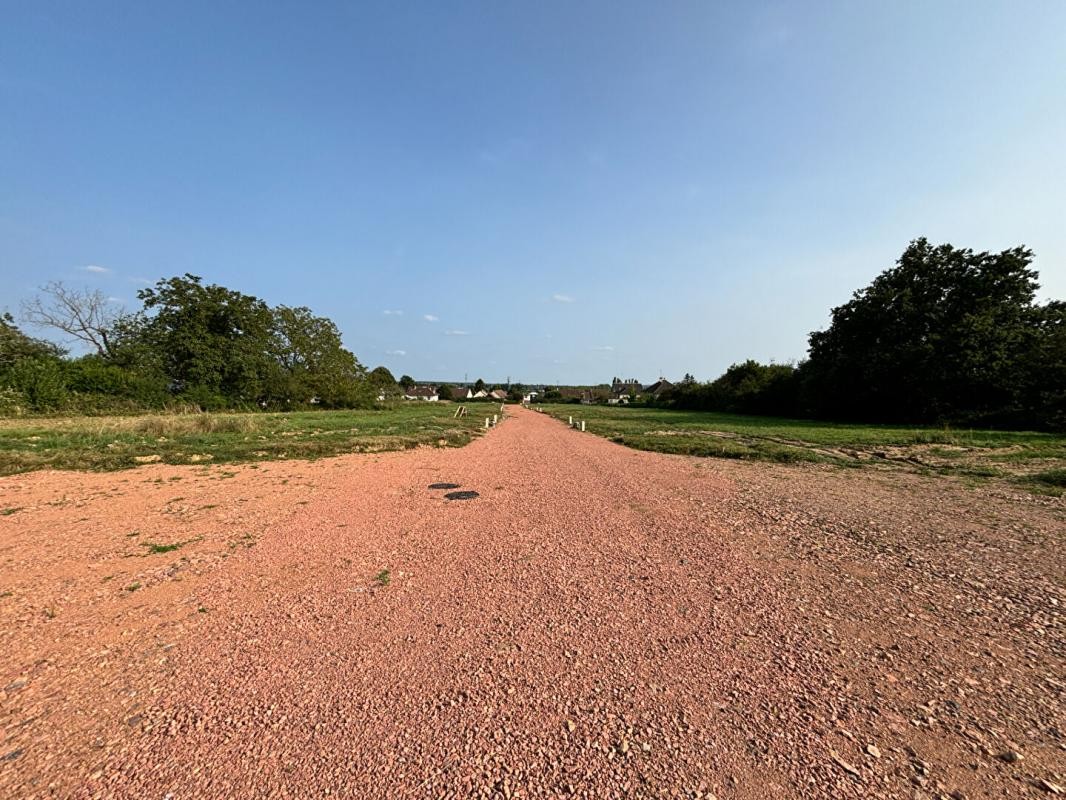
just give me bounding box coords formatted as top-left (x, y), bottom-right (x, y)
top-left (22, 281), bottom-right (122, 356)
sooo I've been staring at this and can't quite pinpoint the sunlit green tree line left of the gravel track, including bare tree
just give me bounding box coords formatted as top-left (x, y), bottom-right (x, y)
top-left (0, 274), bottom-right (383, 413)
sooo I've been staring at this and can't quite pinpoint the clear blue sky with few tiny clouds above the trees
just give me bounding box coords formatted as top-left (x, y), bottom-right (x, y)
top-left (0, 0), bottom-right (1066, 383)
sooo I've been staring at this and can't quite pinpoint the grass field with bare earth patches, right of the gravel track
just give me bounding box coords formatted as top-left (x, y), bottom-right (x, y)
top-left (538, 404), bottom-right (1066, 494)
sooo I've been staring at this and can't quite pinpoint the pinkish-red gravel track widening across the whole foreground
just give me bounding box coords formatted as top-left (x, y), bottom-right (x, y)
top-left (0, 410), bottom-right (1066, 800)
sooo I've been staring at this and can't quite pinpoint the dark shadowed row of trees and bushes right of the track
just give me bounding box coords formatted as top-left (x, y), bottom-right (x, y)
top-left (659, 239), bottom-right (1066, 430)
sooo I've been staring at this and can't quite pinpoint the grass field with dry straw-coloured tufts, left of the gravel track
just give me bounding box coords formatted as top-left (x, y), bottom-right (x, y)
top-left (0, 403), bottom-right (481, 475)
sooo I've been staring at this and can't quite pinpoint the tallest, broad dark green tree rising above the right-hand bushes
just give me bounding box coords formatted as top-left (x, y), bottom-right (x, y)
top-left (803, 239), bottom-right (1047, 421)
